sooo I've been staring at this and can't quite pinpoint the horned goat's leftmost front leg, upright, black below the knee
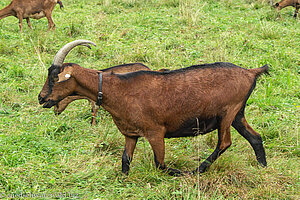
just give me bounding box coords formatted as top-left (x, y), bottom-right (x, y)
top-left (122, 136), bottom-right (138, 175)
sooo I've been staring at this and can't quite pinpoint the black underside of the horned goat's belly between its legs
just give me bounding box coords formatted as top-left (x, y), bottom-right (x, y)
top-left (165, 117), bottom-right (218, 138)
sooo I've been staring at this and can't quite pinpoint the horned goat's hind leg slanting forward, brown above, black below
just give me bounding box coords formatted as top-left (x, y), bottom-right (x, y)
top-left (193, 123), bottom-right (231, 173)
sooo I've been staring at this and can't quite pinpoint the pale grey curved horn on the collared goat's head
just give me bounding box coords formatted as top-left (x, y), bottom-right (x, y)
top-left (53, 40), bottom-right (96, 66)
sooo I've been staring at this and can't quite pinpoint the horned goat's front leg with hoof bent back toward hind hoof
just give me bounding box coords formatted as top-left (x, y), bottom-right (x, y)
top-left (147, 135), bottom-right (182, 176)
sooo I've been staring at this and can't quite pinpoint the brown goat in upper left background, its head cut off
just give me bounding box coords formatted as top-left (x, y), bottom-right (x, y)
top-left (0, 0), bottom-right (63, 32)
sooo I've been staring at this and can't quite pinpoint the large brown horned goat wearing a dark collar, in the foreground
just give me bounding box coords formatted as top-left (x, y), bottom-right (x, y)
top-left (39, 40), bottom-right (268, 175)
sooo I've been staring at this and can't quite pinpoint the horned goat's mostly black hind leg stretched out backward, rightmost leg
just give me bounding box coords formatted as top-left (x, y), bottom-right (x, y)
top-left (232, 109), bottom-right (267, 166)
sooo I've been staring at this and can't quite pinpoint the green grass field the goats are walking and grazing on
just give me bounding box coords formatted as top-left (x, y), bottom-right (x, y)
top-left (0, 0), bottom-right (300, 199)
